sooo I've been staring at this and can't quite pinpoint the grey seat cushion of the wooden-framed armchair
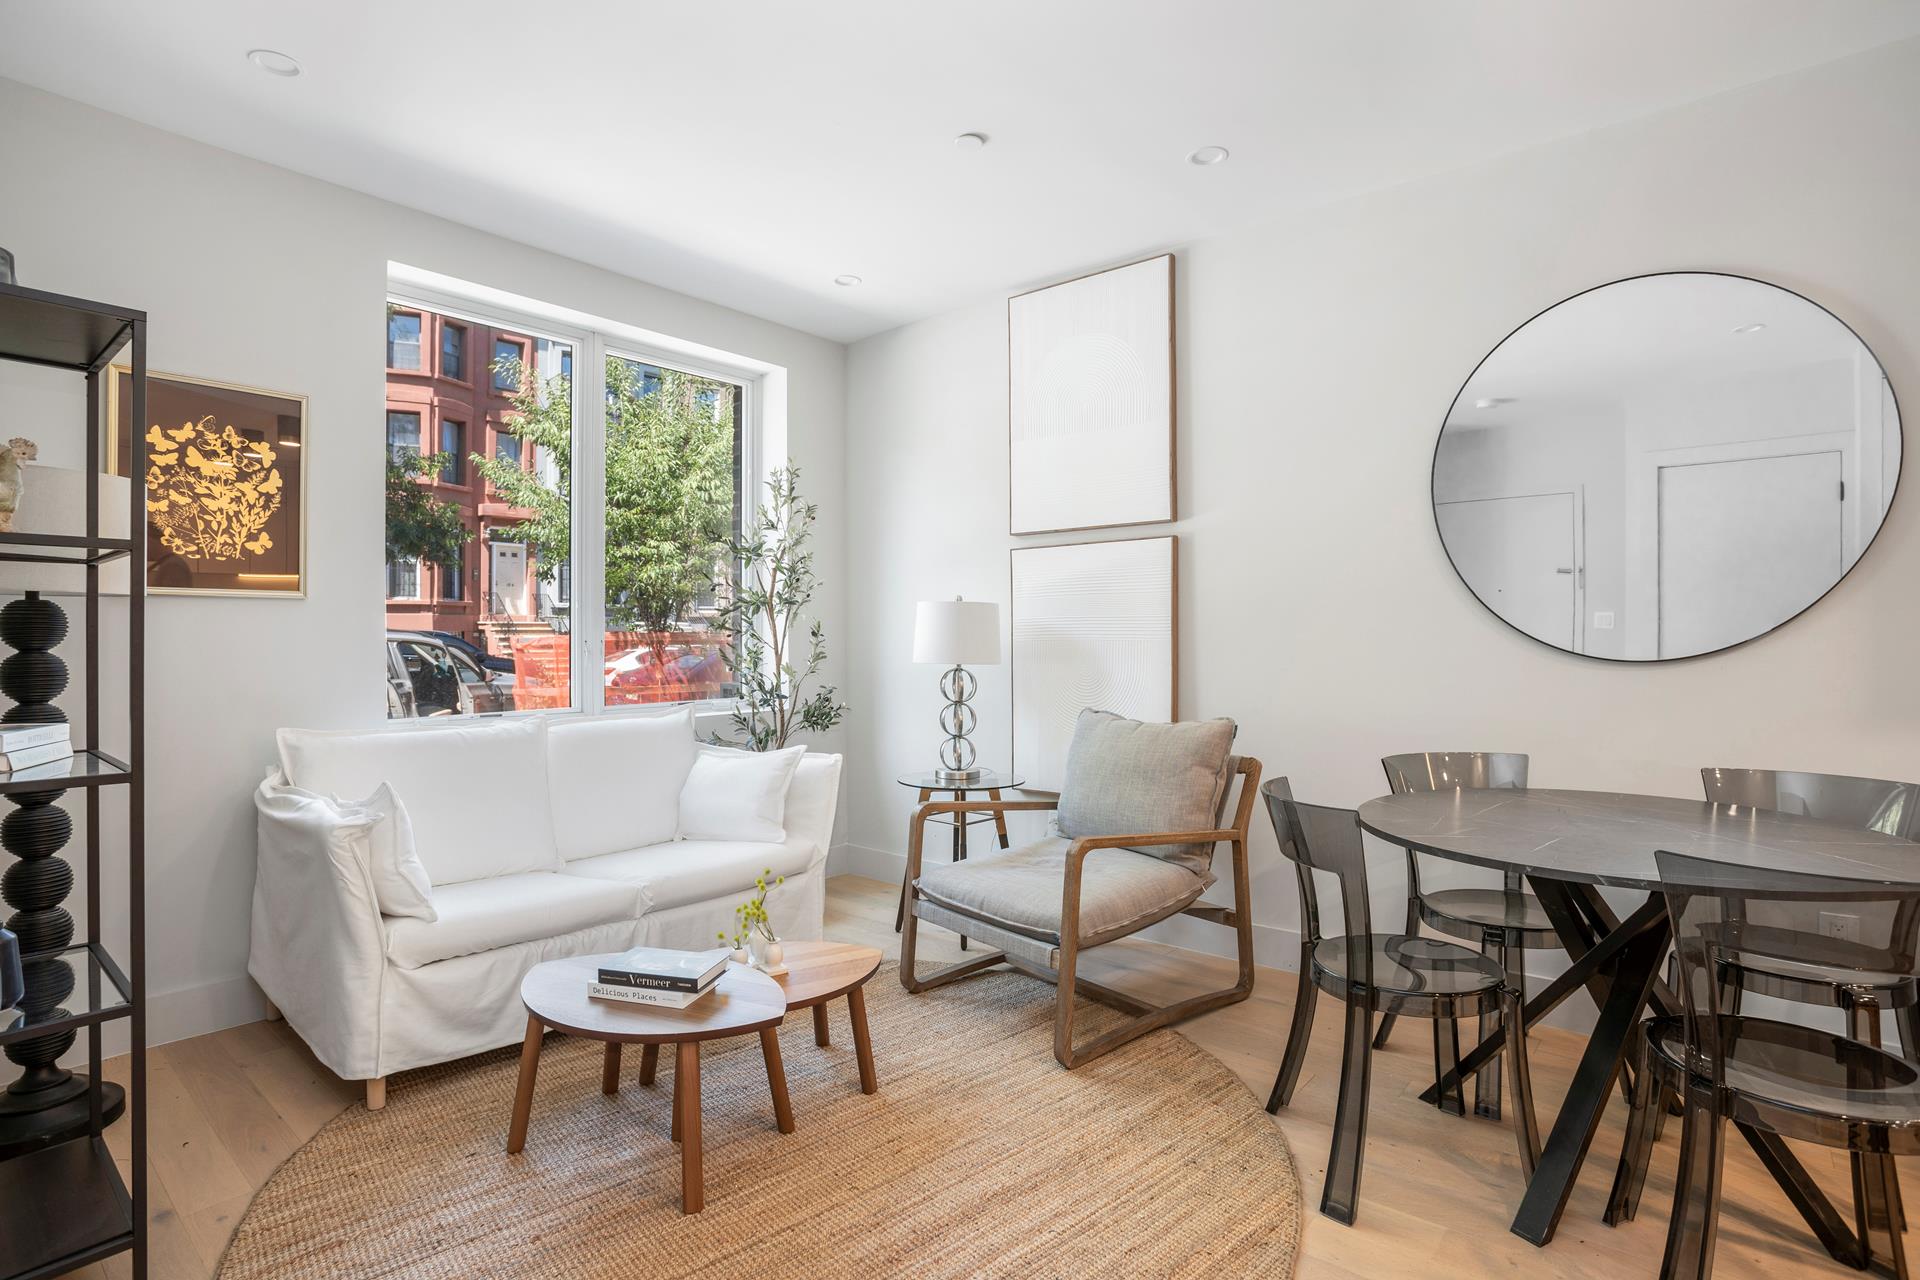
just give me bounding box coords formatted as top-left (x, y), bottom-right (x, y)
top-left (914, 837), bottom-right (1208, 946)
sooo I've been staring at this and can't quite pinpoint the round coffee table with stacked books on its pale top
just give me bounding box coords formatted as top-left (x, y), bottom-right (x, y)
top-left (507, 956), bottom-right (791, 1213)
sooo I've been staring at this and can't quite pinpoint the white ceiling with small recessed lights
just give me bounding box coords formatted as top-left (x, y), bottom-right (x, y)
top-left (0, 0), bottom-right (1920, 340)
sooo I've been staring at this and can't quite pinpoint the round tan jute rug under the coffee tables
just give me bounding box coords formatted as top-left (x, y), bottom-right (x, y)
top-left (219, 965), bottom-right (1300, 1280)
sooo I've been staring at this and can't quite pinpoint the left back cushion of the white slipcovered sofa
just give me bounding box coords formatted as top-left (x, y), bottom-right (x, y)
top-left (278, 716), bottom-right (561, 886)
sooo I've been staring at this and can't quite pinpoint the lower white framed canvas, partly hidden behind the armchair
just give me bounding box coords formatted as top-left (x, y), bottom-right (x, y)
top-left (1010, 537), bottom-right (1179, 791)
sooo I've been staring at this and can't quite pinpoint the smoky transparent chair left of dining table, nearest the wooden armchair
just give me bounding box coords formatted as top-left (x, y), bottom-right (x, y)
top-left (1260, 777), bottom-right (1540, 1224)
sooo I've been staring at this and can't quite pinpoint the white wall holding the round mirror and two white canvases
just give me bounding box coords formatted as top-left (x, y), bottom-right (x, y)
top-left (843, 42), bottom-right (1920, 997)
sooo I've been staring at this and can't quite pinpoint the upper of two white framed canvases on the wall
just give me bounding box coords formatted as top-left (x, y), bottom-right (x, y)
top-left (1006, 253), bottom-right (1173, 533)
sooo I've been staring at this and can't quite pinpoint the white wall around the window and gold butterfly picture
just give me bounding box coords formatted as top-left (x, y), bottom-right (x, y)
top-left (0, 81), bottom-right (847, 1040)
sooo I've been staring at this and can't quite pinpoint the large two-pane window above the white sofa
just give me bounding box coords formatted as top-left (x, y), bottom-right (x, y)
top-left (388, 297), bottom-right (756, 716)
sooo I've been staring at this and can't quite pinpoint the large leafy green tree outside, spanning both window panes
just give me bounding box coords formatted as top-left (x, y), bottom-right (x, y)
top-left (474, 355), bottom-right (739, 651)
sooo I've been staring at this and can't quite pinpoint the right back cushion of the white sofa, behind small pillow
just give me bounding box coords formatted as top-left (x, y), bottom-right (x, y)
top-left (547, 708), bottom-right (699, 862)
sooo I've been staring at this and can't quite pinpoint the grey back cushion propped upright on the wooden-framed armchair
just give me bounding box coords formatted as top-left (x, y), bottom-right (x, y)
top-left (1056, 710), bottom-right (1235, 877)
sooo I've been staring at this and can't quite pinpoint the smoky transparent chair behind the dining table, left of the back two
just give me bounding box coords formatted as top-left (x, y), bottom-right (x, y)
top-left (1373, 750), bottom-right (1561, 1121)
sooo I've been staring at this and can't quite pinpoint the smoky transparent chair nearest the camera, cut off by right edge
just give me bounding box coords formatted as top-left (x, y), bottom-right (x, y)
top-left (1617, 852), bottom-right (1920, 1280)
